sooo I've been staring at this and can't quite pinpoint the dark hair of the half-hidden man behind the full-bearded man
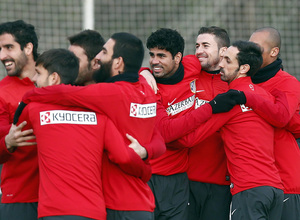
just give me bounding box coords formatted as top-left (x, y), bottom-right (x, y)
top-left (68, 30), bottom-right (105, 61)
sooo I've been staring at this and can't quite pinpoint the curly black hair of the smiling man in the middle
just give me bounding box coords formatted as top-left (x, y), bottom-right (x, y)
top-left (146, 28), bottom-right (184, 58)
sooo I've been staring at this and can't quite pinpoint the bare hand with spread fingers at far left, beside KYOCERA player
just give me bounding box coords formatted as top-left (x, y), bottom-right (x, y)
top-left (5, 121), bottom-right (36, 153)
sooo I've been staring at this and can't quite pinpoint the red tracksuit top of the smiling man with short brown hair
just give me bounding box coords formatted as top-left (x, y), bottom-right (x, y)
top-left (187, 70), bottom-right (230, 185)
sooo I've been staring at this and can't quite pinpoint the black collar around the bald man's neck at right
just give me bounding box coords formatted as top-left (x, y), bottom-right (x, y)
top-left (251, 58), bottom-right (282, 84)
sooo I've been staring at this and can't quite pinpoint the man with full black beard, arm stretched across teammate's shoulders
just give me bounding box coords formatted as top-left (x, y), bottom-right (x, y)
top-left (19, 33), bottom-right (165, 220)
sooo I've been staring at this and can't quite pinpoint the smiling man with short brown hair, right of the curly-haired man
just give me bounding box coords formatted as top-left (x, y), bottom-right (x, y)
top-left (187, 26), bottom-right (231, 220)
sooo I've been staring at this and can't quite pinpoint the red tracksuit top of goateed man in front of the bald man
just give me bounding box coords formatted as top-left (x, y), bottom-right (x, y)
top-left (169, 77), bottom-right (283, 195)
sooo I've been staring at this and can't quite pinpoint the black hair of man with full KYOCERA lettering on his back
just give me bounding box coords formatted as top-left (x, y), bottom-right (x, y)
top-left (35, 49), bottom-right (79, 85)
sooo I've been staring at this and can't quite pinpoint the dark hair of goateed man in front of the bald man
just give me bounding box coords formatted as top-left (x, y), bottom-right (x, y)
top-left (232, 41), bottom-right (263, 76)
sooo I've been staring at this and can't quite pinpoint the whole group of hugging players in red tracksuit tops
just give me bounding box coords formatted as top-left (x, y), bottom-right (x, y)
top-left (0, 20), bottom-right (300, 220)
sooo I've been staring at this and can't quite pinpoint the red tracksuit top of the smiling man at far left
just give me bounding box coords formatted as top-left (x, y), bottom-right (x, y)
top-left (0, 76), bottom-right (39, 203)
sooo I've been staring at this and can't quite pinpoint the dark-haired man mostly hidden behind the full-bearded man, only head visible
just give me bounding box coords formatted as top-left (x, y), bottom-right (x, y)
top-left (68, 30), bottom-right (105, 86)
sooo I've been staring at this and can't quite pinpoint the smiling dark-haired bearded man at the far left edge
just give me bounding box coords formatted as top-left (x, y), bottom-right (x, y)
top-left (0, 20), bottom-right (39, 220)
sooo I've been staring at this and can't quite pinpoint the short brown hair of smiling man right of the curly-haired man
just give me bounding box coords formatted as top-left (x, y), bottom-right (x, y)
top-left (198, 26), bottom-right (230, 49)
